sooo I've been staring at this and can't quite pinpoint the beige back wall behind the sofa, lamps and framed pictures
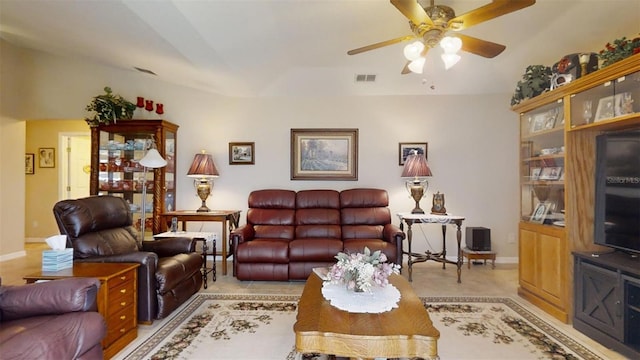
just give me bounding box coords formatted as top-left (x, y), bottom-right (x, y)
top-left (0, 41), bottom-right (519, 260)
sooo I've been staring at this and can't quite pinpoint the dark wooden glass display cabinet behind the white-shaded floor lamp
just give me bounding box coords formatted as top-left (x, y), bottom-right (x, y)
top-left (90, 120), bottom-right (178, 237)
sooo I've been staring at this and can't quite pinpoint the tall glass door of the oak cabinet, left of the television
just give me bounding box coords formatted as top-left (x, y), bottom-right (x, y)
top-left (520, 101), bottom-right (565, 226)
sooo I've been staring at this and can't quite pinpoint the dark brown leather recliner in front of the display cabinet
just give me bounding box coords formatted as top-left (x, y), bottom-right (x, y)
top-left (53, 196), bottom-right (202, 323)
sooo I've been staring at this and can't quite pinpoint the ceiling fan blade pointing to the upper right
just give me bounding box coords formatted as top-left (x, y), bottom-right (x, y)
top-left (450, 0), bottom-right (536, 31)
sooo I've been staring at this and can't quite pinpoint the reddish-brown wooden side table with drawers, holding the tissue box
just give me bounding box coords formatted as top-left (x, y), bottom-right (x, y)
top-left (24, 262), bottom-right (140, 359)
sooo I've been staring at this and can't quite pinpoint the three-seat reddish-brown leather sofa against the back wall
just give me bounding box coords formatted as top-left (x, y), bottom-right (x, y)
top-left (231, 189), bottom-right (405, 281)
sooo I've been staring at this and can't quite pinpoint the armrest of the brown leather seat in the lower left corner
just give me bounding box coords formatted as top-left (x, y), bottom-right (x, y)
top-left (0, 278), bottom-right (100, 321)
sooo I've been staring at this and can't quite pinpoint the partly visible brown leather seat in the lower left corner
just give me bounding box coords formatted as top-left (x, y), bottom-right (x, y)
top-left (0, 278), bottom-right (107, 360)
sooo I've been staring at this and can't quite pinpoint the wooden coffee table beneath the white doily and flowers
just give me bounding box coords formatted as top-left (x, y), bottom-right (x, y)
top-left (293, 272), bottom-right (440, 360)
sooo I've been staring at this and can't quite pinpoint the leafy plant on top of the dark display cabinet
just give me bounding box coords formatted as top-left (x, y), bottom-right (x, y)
top-left (85, 86), bottom-right (136, 127)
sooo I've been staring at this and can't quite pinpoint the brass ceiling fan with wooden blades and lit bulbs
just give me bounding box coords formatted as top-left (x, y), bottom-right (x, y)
top-left (347, 0), bottom-right (536, 74)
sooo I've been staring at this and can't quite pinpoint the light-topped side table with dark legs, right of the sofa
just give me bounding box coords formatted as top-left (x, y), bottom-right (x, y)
top-left (398, 212), bottom-right (464, 283)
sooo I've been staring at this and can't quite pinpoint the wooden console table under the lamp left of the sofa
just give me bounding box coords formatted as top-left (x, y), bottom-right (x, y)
top-left (160, 210), bottom-right (240, 275)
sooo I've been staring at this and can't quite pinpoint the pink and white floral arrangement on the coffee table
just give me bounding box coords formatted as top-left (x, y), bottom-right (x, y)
top-left (325, 247), bottom-right (400, 292)
